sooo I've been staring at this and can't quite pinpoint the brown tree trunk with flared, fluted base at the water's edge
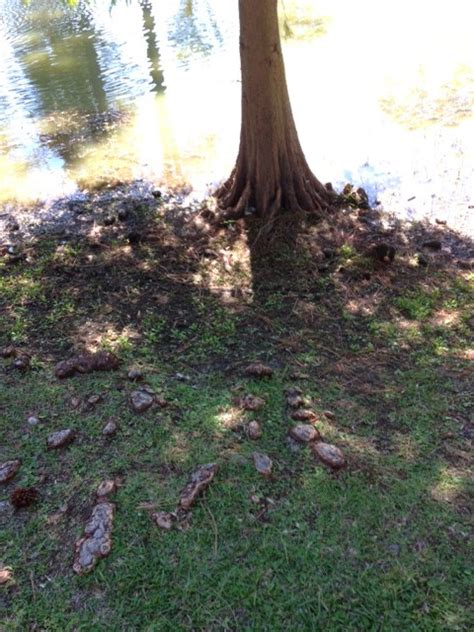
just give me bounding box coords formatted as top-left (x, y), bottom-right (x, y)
top-left (216, 0), bottom-right (331, 223)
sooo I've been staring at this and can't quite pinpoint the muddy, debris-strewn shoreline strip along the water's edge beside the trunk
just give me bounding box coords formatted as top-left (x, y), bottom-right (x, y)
top-left (0, 180), bottom-right (472, 247)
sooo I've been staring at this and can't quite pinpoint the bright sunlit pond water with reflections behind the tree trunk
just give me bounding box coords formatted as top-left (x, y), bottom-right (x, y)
top-left (0, 0), bottom-right (474, 232)
